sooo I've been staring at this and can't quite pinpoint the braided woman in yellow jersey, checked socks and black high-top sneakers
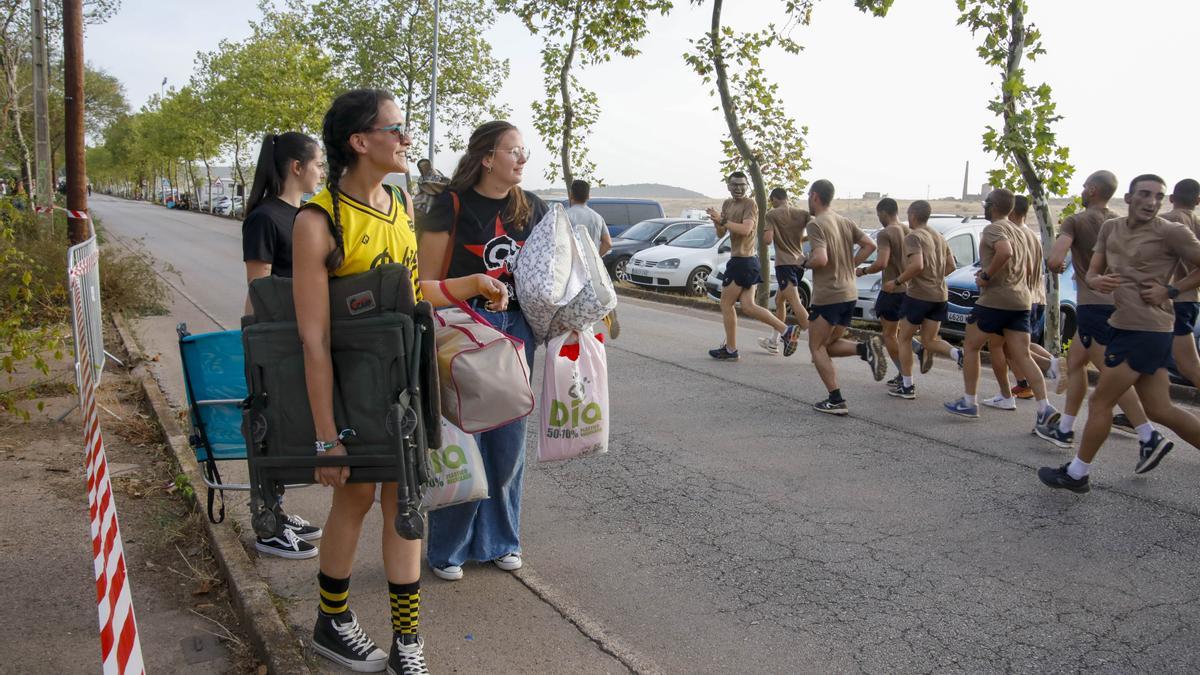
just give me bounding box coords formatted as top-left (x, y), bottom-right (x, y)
top-left (293, 89), bottom-right (508, 675)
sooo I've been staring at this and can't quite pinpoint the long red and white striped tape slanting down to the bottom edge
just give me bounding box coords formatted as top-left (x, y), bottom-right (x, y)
top-left (71, 273), bottom-right (145, 675)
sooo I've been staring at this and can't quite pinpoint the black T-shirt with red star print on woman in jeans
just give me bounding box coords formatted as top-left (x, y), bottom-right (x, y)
top-left (416, 187), bottom-right (550, 309)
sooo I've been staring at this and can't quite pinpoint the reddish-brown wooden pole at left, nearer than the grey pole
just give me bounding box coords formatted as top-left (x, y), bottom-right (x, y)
top-left (62, 0), bottom-right (91, 245)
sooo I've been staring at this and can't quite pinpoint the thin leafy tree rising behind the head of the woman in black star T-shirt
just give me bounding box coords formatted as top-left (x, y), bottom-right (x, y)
top-left (497, 0), bottom-right (672, 190)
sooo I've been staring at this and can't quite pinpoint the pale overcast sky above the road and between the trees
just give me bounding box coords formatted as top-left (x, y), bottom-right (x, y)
top-left (84, 0), bottom-right (1200, 198)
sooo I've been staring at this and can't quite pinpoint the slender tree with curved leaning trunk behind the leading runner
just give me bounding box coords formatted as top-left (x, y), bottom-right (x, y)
top-left (684, 0), bottom-right (892, 303)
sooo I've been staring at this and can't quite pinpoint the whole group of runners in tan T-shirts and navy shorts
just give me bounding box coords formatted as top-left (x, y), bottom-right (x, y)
top-left (709, 171), bottom-right (1200, 492)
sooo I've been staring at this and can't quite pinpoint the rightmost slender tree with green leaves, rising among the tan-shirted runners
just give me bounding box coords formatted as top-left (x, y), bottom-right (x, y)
top-left (956, 0), bottom-right (1075, 354)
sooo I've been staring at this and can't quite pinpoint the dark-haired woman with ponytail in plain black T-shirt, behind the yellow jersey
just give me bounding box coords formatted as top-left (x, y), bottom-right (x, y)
top-left (241, 131), bottom-right (324, 560)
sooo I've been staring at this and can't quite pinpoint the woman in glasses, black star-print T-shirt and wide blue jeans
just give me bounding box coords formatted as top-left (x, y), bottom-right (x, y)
top-left (418, 121), bottom-right (547, 581)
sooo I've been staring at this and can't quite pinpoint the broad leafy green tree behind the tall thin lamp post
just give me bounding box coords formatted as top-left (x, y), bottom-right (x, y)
top-left (302, 0), bottom-right (509, 154)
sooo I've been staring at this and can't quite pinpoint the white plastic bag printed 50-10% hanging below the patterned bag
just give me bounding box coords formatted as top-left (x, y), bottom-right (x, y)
top-left (538, 331), bottom-right (608, 461)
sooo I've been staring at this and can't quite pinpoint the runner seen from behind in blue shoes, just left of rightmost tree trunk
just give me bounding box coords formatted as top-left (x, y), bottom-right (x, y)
top-left (946, 190), bottom-right (1057, 437)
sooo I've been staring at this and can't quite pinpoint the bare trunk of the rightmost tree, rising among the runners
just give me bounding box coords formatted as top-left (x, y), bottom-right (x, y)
top-left (1003, 0), bottom-right (1062, 356)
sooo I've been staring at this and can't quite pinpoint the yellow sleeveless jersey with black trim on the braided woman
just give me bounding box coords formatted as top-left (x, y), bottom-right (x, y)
top-left (302, 186), bottom-right (421, 300)
